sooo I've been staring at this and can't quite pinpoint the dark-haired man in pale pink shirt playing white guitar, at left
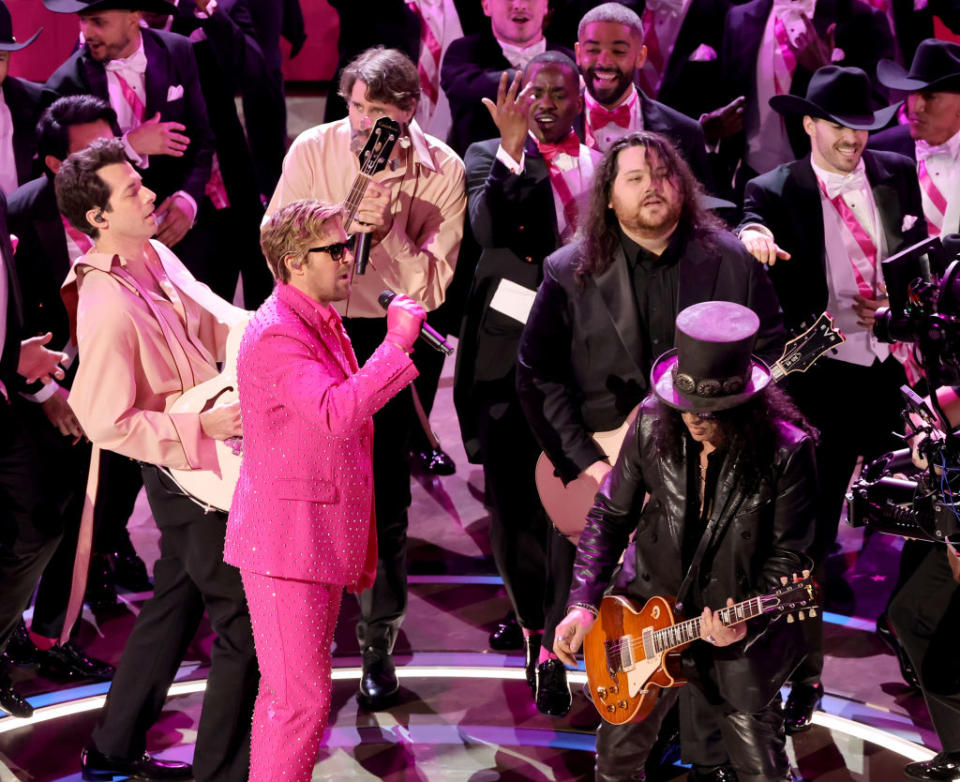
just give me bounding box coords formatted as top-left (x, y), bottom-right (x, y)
top-left (55, 138), bottom-right (259, 782)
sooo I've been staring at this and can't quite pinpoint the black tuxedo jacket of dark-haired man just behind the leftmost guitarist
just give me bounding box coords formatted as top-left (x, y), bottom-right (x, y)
top-left (8, 175), bottom-right (70, 360)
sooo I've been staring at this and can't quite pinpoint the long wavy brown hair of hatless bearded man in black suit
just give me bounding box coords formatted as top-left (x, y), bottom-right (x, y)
top-left (574, 130), bottom-right (725, 287)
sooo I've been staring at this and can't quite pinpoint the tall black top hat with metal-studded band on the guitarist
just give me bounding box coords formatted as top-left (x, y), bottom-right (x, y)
top-left (650, 301), bottom-right (770, 413)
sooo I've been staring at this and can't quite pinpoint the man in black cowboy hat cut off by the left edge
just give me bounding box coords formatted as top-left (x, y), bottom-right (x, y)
top-left (0, 0), bottom-right (43, 196)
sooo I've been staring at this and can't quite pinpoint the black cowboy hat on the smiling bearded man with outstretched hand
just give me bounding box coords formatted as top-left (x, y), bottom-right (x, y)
top-left (770, 65), bottom-right (898, 130)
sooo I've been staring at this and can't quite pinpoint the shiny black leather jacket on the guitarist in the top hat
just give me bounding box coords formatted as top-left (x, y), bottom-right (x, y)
top-left (570, 397), bottom-right (817, 712)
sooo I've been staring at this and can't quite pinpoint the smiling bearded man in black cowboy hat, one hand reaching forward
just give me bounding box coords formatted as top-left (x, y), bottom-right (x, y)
top-left (739, 65), bottom-right (926, 732)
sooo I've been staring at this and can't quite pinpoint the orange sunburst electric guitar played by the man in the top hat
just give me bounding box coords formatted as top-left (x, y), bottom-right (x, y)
top-left (583, 571), bottom-right (819, 725)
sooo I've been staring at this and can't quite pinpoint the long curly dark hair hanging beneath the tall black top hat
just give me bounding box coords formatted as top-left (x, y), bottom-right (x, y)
top-left (653, 384), bottom-right (820, 485)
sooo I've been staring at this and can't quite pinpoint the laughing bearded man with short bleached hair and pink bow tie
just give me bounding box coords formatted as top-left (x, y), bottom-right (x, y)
top-left (575, 3), bottom-right (712, 189)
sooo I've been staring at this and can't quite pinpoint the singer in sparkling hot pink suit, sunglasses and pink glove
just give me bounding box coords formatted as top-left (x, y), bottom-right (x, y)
top-left (224, 199), bottom-right (425, 782)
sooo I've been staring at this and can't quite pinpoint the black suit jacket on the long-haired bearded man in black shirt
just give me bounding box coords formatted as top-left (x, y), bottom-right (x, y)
top-left (517, 231), bottom-right (783, 481)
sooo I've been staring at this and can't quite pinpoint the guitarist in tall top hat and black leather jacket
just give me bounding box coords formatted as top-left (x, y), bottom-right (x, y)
top-left (554, 301), bottom-right (816, 782)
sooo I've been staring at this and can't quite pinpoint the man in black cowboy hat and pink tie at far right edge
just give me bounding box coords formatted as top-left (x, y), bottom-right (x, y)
top-left (869, 38), bottom-right (960, 236)
